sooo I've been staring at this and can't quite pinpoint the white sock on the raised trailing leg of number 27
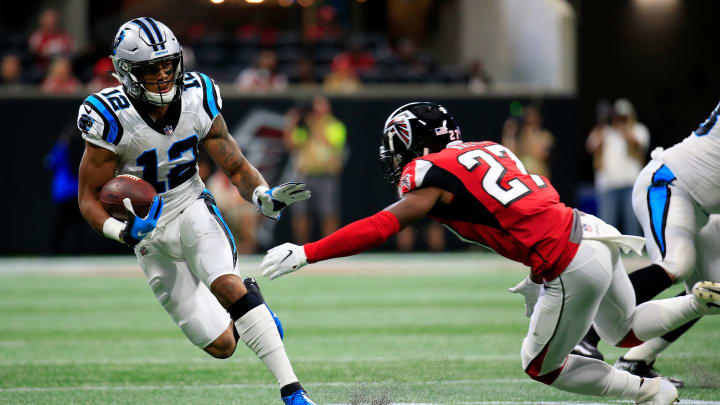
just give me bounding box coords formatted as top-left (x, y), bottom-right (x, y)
top-left (632, 295), bottom-right (707, 341)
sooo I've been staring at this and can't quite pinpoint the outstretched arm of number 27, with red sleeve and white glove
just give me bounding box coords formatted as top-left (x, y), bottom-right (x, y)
top-left (260, 187), bottom-right (452, 279)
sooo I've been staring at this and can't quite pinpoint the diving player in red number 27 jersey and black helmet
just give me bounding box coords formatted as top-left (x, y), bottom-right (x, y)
top-left (261, 102), bottom-right (720, 404)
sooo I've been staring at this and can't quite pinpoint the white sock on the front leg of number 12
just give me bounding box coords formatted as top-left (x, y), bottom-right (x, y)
top-left (228, 294), bottom-right (298, 387)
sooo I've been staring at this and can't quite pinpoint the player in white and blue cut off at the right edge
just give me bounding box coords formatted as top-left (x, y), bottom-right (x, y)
top-left (575, 100), bottom-right (720, 387)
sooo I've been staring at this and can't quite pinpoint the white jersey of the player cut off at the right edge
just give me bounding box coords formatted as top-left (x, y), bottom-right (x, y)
top-left (654, 104), bottom-right (720, 213)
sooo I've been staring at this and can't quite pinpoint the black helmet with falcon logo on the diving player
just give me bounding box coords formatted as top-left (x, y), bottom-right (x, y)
top-left (380, 101), bottom-right (461, 189)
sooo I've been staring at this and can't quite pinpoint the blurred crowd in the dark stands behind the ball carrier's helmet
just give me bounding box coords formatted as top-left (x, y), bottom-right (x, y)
top-left (0, 5), bottom-right (491, 94)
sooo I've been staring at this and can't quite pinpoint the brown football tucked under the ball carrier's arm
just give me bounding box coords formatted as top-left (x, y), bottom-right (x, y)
top-left (100, 174), bottom-right (157, 221)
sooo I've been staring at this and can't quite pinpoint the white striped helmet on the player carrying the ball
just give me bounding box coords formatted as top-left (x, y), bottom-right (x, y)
top-left (110, 17), bottom-right (184, 106)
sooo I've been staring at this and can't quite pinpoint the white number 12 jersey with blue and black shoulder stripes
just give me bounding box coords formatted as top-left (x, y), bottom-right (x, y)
top-left (78, 72), bottom-right (222, 224)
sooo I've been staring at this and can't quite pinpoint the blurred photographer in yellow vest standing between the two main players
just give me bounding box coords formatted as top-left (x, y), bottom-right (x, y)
top-left (285, 96), bottom-right (346, 243)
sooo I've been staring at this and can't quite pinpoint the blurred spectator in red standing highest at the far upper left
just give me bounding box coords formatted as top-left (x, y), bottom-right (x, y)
top-left (29, 8), bottom-right (74, 71)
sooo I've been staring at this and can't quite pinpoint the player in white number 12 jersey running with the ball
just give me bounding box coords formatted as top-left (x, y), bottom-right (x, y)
top-left (78, 17), bottom-right (313, 404)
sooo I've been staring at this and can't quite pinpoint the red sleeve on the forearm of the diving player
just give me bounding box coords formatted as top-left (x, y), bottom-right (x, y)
top-left (304, 211), bottom-right (400, 263)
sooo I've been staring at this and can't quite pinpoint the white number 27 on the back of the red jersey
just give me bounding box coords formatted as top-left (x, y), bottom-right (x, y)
top-left (458, 144), bottom-right (547, 207)
